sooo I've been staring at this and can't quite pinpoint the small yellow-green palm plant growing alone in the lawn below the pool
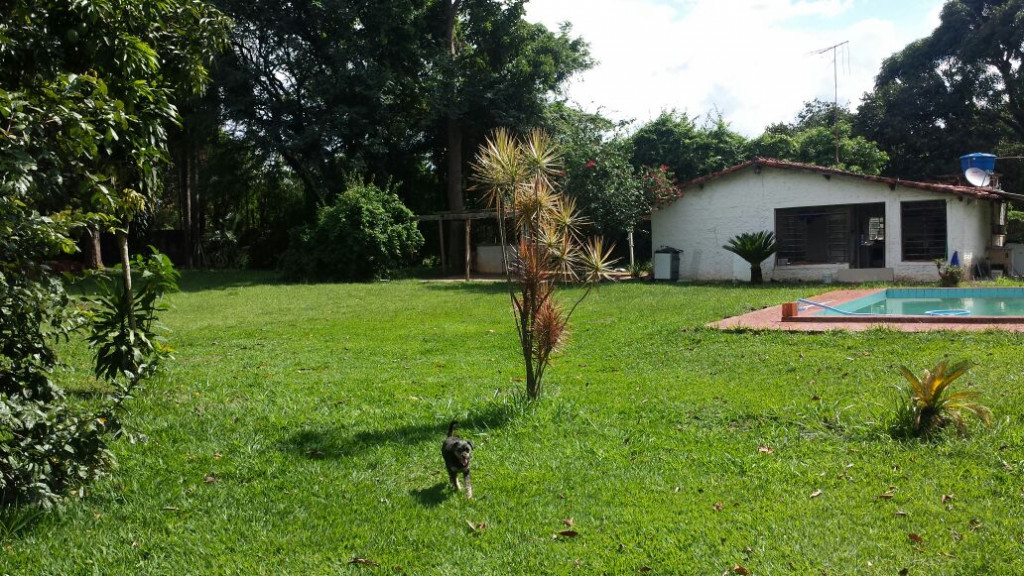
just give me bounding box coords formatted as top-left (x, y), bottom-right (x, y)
top-left (890, 360), bottom-right (992, 438)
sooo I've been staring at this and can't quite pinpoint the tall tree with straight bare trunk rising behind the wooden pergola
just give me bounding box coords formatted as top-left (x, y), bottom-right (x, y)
top-left (427, 0), bottom-right (593, 261)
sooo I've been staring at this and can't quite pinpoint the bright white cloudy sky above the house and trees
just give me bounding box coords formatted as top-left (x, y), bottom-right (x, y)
top-left (526, 0), bottom-right (943, 137)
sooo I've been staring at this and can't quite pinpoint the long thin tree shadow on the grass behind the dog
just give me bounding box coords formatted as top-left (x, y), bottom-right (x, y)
top-left (281, 400), bottom-right (522, 459)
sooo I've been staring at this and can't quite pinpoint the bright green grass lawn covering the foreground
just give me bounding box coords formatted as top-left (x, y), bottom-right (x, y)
top-left (0, 273), bottom-right (1024, 574)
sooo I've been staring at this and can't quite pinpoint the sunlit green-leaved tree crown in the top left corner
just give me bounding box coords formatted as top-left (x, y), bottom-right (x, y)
top-left (0, 0), bottom-right (226, 268)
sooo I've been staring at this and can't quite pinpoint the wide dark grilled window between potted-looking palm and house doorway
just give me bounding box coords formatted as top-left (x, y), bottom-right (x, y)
top-left (775, 206), bottom-right (851, 264)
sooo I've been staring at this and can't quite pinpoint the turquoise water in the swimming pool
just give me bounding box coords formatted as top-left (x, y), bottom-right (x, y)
top-left (817, 288), bottom-right (1024, 317)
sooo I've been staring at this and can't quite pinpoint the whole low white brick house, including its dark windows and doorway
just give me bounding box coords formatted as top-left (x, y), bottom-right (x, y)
top-left (651, 158), bottom-right (1006, 282)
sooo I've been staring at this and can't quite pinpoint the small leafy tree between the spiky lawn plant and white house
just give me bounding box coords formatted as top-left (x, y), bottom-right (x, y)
top-left (544, 102), bottom-right (650, 236)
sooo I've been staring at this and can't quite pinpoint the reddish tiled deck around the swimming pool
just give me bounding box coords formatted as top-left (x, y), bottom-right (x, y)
top-left (708, 288), bottom-right (1024, 332)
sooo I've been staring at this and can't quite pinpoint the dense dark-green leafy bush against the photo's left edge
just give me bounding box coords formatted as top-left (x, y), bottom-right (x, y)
top-left (0, 199), bottom-right (110, 504)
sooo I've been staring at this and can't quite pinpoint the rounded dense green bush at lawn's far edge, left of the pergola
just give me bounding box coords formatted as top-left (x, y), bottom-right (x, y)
top-left (282, 178), bottom-right (424, 281)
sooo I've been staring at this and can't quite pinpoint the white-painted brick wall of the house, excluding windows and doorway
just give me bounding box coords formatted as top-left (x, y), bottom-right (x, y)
top-left (651, 167), bottom-right (990, 281)
